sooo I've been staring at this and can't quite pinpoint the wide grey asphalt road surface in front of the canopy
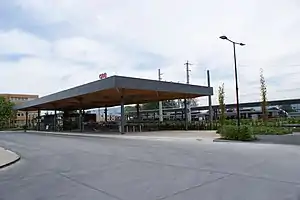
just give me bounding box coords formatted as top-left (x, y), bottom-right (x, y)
top-left (0, 132), bottom-right (300, 200)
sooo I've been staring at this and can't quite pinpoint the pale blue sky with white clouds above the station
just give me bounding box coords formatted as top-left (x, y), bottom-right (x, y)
top-left (0, 0), bottom-right (300, 103)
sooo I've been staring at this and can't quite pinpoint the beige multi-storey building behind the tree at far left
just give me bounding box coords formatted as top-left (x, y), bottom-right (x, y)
top-left (0, 94), bottom-right (39, 127)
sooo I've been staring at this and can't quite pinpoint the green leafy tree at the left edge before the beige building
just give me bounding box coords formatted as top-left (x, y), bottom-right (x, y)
top-left (0, 97), bottom-right (16, 129)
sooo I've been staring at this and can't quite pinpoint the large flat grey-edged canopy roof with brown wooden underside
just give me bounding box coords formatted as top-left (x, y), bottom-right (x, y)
top-left (14, 76), bottom-right (213, 110)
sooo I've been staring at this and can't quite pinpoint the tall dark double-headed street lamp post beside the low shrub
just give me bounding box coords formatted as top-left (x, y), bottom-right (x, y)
top-left (220, 35), bottom-right (245, 127)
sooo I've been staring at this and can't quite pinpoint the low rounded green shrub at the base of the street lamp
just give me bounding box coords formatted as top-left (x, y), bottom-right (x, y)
top-left (218, 125), bottom-right (256, 141)
